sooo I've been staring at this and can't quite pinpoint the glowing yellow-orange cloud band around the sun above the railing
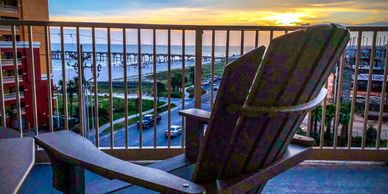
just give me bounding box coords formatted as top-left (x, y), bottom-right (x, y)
top-left (50, 1), bottom-right (388, 25)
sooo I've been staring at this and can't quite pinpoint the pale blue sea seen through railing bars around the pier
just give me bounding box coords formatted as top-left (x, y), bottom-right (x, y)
top-left (51, 43), bottom-right (253, 84)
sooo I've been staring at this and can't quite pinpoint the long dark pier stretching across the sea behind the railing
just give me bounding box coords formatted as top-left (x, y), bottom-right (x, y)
top-left (51, 50), bottom-right (225, 63)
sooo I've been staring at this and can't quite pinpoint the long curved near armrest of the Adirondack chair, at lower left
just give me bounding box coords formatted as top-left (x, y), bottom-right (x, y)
top-left (35, 131), bottom-right (205, 193)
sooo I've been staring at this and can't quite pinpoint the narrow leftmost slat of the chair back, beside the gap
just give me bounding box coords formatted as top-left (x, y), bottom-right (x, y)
top-left (192, 46), bottom-right (265, 182)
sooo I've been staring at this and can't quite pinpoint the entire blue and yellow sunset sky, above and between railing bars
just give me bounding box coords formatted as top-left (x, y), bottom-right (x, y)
top-left (49, 0), bottom-right (388, 46)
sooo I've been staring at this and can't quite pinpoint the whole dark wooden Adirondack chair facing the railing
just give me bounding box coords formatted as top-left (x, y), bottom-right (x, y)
top-left (36, 24), bottom-right (349, 193)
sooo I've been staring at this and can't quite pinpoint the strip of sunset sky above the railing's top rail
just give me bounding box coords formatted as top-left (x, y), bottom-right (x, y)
top-left (49, 0), bottom-right (388, 25)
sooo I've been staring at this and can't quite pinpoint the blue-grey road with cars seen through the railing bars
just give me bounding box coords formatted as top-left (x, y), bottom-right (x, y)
top-left (100, 83), bottom-right (217, 147)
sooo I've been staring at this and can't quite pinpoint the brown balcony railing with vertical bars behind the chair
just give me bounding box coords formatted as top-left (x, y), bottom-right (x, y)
top-left (0, 20), bottom-right (388, 161)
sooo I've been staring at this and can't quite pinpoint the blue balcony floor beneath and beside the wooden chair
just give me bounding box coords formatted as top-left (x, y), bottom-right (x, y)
top-left (20, 162), bottom-right (388, 194)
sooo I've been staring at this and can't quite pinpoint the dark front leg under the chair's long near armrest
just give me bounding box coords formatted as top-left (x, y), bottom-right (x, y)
top-left (49, 154), bottom-right (85, 194)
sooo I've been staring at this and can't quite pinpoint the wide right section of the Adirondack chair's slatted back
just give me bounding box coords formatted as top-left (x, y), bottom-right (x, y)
top-left (193, 24), bottom-right (349, 182)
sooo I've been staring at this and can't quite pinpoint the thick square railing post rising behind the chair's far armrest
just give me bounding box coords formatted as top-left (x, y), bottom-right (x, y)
top-left (194, 30), bottom-right (203, 108)
